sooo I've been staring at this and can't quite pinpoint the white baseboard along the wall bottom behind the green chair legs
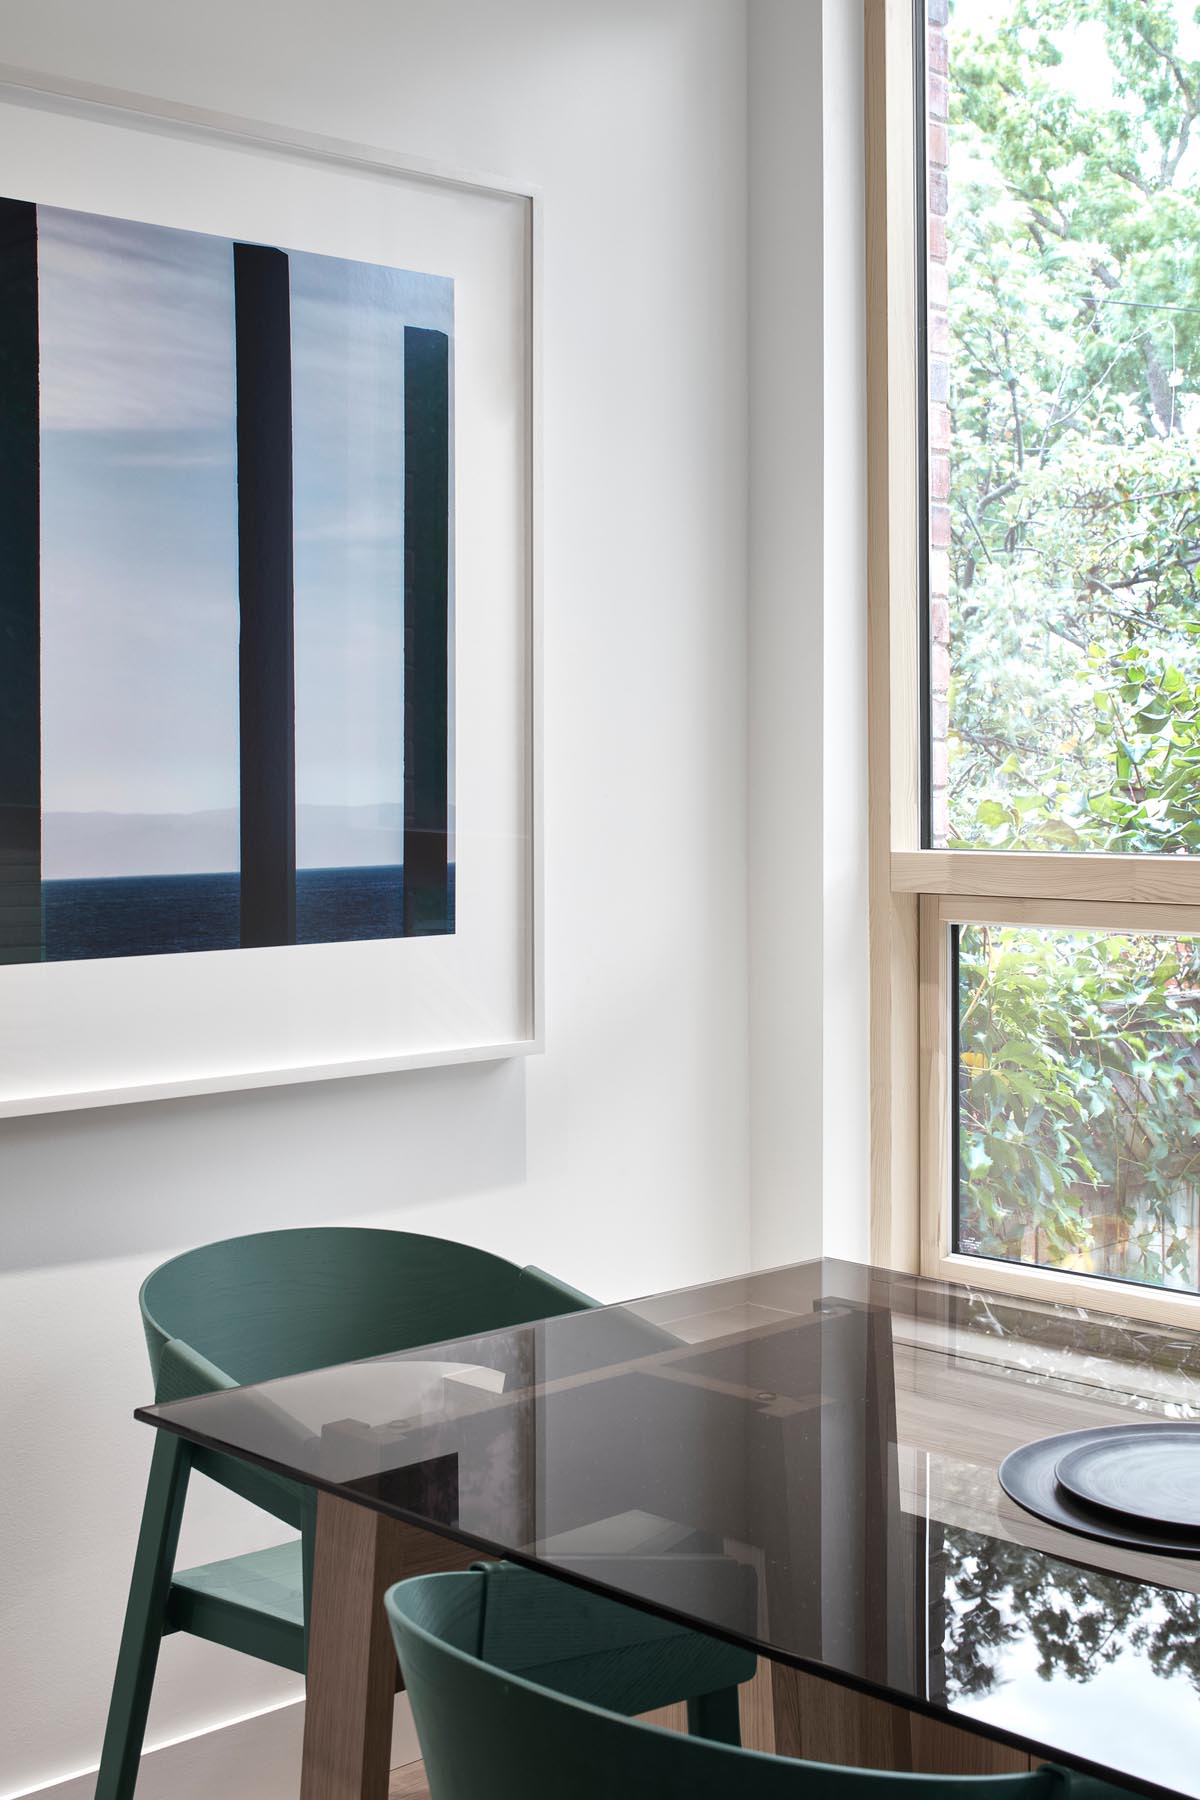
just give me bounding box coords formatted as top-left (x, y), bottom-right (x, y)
top-left (5, 1694), bottom-right (419, 1800)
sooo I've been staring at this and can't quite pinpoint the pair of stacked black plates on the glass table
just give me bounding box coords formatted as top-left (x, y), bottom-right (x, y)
top-left (999, 1420), bottom-right (1200, 1557)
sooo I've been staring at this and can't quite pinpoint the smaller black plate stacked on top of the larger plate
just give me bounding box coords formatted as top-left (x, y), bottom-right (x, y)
top-left (1054, 1424), bottom-right (1200, 1532)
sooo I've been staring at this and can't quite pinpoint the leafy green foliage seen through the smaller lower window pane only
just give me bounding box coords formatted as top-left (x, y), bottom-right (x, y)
top-left (959, 927), bottom-right (1200, 1285)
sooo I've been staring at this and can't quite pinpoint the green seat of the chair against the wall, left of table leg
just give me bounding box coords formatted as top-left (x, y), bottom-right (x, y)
top-left (167, 1537), bottom-right (304, 1674)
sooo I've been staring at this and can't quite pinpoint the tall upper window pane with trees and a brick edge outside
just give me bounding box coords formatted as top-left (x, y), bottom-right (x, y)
top-left (923, 0), bottom-right (1200, 853)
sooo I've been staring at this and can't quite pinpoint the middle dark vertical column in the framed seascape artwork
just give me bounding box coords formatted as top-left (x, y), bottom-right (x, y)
top-left (234, 243), bottom-right (295, 949)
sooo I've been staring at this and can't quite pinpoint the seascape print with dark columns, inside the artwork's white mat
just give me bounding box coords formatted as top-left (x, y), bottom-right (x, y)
top-left (0, 200), bottom-right (455, 963)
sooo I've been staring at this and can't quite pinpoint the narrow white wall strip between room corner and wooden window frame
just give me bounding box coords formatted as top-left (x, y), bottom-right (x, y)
top-left (748, 0), bottom-right (869, 1267)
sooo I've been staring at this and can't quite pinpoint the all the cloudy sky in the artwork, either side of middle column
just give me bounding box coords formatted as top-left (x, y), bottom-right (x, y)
top-left (38, 207), bottom-right (453, 878)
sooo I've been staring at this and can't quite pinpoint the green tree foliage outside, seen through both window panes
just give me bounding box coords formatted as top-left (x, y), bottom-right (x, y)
top-left (948, 0), bottom-right (1200, 1285)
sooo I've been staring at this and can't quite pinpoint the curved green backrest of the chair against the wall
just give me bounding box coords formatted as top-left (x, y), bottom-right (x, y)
top-left (140, 1226), bottom-right (592, 1390)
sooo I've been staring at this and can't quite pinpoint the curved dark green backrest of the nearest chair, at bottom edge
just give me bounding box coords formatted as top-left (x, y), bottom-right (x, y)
top-left (387, 1564), bottom-right (1067, 1800)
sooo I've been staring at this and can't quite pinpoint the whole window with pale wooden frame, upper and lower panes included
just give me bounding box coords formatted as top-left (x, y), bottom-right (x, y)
top-left (867, 0), bottom-right (1200, 1314)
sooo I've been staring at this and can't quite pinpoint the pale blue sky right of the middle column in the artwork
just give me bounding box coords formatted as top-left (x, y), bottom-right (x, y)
top-left (290, 252), bottom-right (453, 868)
